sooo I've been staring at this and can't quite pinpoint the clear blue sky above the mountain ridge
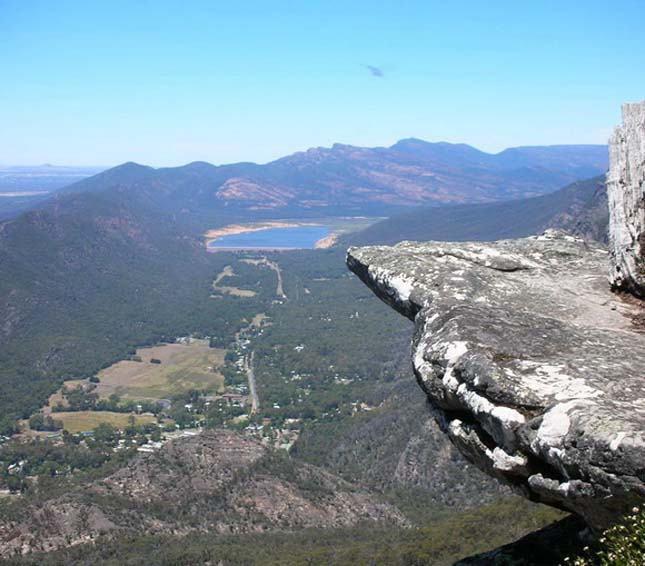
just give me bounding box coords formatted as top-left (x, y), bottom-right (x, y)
top-left (0, 0), bottom-right (645, 166)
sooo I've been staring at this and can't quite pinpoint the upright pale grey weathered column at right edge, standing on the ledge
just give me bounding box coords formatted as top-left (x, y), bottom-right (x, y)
top-left (607, 101), bottom-right (645, 296)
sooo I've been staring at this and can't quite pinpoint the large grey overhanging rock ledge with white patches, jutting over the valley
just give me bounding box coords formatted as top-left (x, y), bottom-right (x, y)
top-left (347, 231), bottom-right (645, 530)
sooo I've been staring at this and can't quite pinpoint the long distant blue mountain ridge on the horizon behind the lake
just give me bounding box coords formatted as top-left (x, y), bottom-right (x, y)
top-left (57, 138), bottom-right (607, 217)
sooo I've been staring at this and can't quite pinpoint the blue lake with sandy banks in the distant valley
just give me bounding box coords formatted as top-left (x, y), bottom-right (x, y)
top-left (208, 226), bottom-right (331, 250)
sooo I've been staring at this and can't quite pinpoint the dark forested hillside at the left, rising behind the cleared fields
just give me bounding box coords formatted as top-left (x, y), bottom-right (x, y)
top-left (0, 186), bottom-right (243, 426)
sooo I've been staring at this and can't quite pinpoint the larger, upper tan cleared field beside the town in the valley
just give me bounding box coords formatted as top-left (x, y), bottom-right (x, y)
top-left (96, 340), bottom-right (226, 400)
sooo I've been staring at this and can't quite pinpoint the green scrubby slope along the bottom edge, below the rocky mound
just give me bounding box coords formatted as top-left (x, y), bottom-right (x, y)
top-left (6, 498), bottom-right (568, 566)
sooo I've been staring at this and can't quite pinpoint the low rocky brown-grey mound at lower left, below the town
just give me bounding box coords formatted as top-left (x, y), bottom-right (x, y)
top-left (0, 430), bottom-right (406, 557)
